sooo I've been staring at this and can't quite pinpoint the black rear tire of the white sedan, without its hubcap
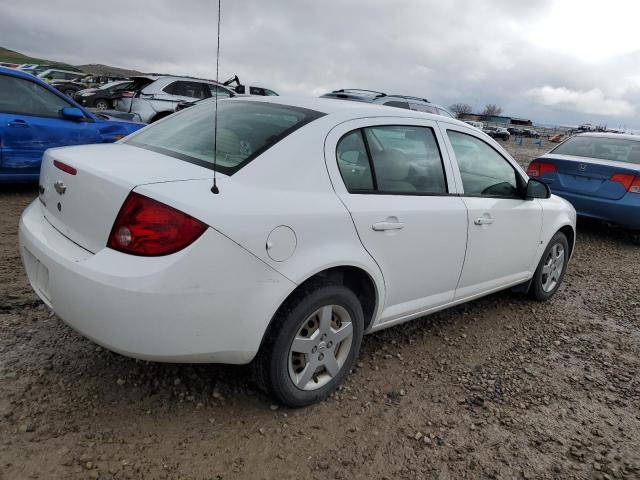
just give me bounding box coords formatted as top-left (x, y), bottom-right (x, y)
top-left (253, 284), bottom-right (364, 407)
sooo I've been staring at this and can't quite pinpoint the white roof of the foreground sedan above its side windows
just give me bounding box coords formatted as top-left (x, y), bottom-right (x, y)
top-left (225, 96), bottom-right (468, 127)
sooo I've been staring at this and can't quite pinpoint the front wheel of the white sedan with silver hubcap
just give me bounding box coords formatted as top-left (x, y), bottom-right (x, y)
top-left (530, 232), bottom-right (569, 301)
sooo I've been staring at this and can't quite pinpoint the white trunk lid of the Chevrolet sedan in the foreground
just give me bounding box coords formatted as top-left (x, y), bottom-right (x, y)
top-left (39, 144), bottom-right (213, 253)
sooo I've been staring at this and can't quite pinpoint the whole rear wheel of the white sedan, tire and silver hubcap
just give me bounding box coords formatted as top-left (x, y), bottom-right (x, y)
top-left (254, 285), bottom-right (364, 407)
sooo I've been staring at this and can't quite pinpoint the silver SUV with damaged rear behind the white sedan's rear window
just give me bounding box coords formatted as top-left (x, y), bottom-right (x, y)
top-left (115, 75), bottom-right (235, 123)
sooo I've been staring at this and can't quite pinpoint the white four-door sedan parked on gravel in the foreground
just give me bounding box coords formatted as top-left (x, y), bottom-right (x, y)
top-left (19, 97), bottom-right (575, 406)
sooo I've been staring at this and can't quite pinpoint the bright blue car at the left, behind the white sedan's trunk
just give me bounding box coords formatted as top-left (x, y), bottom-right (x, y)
top-left (0, 67), bottom-right (144, 183)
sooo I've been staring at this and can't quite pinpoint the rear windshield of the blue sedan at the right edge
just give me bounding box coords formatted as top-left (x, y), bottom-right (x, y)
top-left (551, 136), bottom-right (640, 164)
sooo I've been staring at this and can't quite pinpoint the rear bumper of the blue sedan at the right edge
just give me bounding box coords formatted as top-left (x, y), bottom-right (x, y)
top-left (551, 186), bottom-right (640, 230)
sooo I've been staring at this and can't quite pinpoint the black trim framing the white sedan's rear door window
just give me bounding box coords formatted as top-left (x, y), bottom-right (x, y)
top-left (334, 123), bottom-right (452, 197)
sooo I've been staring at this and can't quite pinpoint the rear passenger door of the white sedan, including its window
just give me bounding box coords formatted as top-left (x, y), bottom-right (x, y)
top-left (325, 118), bottom-right (467, 324)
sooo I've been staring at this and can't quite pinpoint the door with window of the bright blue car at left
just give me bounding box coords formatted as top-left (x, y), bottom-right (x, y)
top-left (0, 75), bottom-right (101, 174)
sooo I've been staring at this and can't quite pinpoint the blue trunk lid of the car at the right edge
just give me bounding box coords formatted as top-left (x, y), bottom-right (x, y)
top-left (538, 154), bottom-right (640, 200)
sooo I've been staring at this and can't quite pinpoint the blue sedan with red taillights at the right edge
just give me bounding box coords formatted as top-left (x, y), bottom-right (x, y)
top-left (527, 133), bottom-right (640, 244)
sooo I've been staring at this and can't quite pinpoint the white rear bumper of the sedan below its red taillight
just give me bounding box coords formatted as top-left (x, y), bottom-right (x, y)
top-left (19, 200), bottom-right (295, 364)
